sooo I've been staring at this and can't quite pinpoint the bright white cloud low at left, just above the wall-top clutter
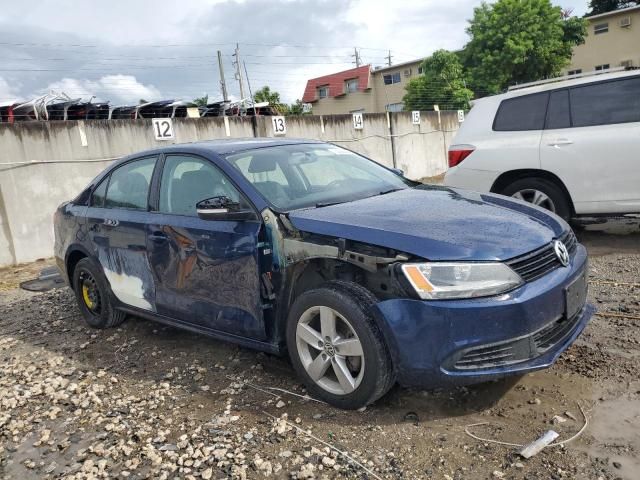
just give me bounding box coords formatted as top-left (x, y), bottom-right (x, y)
top-left (44, 75), bottom-right (162, 105)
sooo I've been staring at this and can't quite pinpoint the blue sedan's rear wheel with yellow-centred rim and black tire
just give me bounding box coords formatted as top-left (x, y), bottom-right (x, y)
top-left (72, 258), bottom-right (127, 329)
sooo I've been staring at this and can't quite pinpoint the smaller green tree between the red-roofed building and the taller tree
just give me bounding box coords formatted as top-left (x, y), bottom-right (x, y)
top-left (402, 50), bottom-right (473, 110)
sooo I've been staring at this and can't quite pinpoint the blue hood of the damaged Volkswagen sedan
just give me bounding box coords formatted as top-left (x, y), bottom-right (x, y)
top-left (289, 186), bottom-right (569, 261)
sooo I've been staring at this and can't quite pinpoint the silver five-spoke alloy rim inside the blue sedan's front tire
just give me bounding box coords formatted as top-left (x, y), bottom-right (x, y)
top-left (296, 306), bottom-right (365, 395)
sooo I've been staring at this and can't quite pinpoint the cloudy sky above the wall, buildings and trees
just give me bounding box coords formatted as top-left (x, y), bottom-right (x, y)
top-left (0, 0), bottom-right (587, 105)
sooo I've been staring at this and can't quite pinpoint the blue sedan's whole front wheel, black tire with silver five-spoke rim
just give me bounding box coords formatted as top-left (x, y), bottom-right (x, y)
top-left (287, 281), bottom-right (395, 409)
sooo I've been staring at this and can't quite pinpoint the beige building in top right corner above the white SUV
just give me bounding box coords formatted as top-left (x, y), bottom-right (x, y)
top-left (565, 5), bottom-right (640, 75)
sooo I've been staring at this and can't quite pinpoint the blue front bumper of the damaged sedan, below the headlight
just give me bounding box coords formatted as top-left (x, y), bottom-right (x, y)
top-left (376, 245), bottom-right (595, 387)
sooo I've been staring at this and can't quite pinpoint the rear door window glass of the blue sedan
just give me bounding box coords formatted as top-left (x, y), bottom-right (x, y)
top-left (104, 157), bottom-right (156, 210)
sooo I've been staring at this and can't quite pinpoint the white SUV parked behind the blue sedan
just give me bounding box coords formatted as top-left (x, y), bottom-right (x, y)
top-left (444, 70), bottom-right (640, 219)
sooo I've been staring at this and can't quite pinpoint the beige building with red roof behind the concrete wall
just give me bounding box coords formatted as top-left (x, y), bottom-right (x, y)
top-left (302, 58), bottom-right (424, 115)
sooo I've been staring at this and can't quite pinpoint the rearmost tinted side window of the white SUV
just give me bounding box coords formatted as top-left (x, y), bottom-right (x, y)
top-left (493, 92), bottom-right (549, 132)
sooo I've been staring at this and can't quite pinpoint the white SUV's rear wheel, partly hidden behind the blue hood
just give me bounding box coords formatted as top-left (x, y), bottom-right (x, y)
top-left (500, 177), bottom-right (571, 222)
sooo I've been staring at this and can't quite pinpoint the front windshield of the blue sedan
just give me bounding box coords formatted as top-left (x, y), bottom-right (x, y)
top-left (226, 144), bottom-right (413, 211)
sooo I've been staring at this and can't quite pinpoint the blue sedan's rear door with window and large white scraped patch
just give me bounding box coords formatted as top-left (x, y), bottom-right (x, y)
top-left (87, 156), bottom-right (157, 311)
